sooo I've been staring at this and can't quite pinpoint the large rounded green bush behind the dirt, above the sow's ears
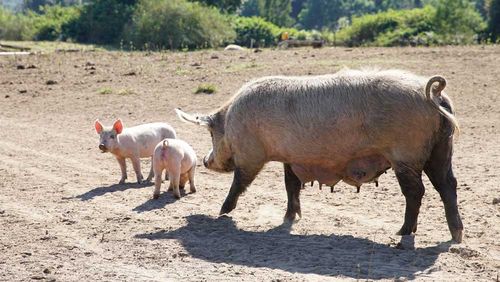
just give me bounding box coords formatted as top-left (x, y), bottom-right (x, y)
top-left (125, 0), bottom-right (235, 49)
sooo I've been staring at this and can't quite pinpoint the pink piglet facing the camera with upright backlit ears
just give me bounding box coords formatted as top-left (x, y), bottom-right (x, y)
top-left (95, 119), bottom-right (176, 184)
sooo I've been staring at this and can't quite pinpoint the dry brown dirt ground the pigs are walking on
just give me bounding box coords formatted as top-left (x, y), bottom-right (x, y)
top-left (0, 46), bottom-right (500, 281)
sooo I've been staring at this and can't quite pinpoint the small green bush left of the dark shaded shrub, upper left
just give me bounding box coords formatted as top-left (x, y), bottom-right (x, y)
top-left (32, 5), bottom-right (80, 40)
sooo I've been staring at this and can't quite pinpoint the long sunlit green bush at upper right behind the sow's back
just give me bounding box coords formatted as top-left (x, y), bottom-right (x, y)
top-left (338, 0), bottom-right (485, 46)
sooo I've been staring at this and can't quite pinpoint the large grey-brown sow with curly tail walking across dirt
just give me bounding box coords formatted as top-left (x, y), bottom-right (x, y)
top-left (177, 70), bottom-right (463, 242)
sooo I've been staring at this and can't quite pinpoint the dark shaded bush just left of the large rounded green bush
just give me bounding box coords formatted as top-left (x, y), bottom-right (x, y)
top-left (62, 0), bottom-right (136, 44)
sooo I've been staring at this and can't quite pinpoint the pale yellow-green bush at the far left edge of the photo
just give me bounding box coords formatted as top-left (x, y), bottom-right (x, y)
top-left (0, 6), bottom-right (34, 40)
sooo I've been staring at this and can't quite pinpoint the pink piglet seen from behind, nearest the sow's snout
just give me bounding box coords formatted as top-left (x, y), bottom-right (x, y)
top-left (153, 139), bottom-right (196, 199)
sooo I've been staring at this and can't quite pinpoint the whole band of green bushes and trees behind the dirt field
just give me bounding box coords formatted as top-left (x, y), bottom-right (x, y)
top-left (0, 0), bottom-right (500, 50)
